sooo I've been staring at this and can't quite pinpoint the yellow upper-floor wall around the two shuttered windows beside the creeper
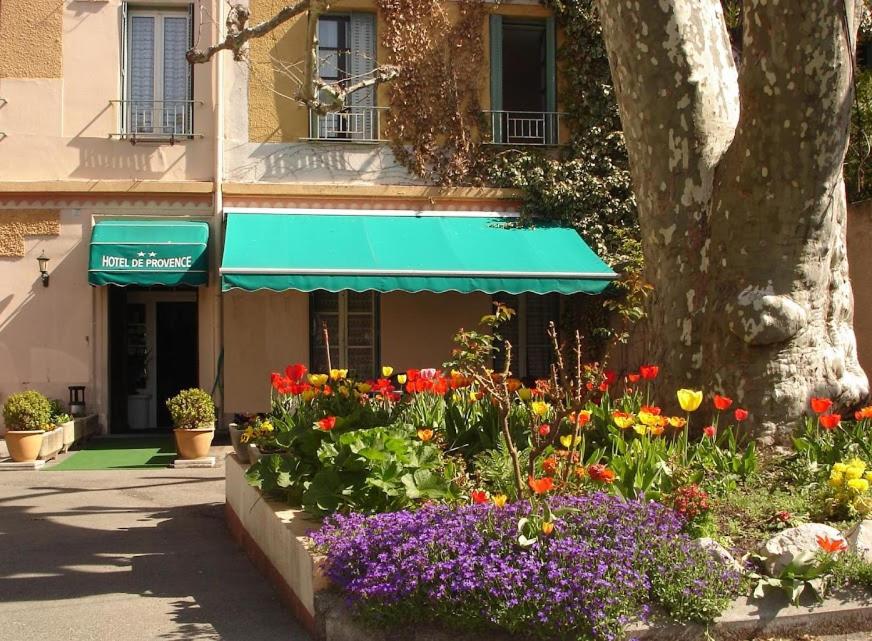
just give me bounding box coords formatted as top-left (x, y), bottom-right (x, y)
top-left (248, 0), bottom-right (562, 142)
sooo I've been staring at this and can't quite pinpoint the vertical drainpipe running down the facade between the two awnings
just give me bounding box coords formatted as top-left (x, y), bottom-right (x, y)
top-left (212, 0), bottom-right (225, 426)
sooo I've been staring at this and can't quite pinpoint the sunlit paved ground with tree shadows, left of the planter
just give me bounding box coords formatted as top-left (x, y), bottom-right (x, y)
top-left (0, 444), bottom-right (308, 641)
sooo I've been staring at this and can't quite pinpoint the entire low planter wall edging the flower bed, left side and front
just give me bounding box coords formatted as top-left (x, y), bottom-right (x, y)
top-left (225, 454), bottom-right (872, 641)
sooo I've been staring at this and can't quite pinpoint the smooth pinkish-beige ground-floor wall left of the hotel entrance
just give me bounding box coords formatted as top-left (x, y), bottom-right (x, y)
top-left (0, 213), bottom-right (94, 416)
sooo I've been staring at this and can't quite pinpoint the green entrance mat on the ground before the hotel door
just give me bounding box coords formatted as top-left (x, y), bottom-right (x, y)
top-left (43, 436), bottom-right (176, 472)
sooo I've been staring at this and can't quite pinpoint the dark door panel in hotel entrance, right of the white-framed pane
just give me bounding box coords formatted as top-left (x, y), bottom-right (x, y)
top-left (155, 301), bottom-right (198, 428)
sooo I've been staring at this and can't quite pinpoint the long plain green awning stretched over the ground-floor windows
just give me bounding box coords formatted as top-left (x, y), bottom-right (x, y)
top-left (221, 210), bottom-right (617, 294)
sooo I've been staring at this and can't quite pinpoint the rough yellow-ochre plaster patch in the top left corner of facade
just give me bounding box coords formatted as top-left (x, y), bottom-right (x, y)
top-left (0, 0), bottom-right (64, 78)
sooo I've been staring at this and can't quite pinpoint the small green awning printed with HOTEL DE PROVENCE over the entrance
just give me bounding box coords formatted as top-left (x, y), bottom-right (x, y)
top-left (88, 219), bottom-right (209, 287)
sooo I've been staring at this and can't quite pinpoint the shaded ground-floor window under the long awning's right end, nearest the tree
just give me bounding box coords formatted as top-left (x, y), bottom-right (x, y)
top-left (494, 294), bottom-right (560, 379)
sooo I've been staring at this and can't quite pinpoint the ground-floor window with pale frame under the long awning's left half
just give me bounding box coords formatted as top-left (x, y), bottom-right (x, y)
top-left (309, 290), bottom-right (379, 377)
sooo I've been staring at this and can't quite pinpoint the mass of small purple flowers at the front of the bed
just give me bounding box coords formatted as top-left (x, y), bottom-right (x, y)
top-left (314, 493), bottom-right (739, 640)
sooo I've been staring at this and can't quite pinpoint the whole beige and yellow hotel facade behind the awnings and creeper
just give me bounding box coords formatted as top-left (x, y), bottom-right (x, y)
top-left (0, 0), bottom-right (584, 433)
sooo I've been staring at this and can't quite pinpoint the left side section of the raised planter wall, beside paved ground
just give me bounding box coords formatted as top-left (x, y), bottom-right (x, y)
top-left (224, 454), bottom-right (328, 638)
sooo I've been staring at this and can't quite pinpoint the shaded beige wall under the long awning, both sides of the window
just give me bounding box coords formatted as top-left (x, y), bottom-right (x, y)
top-left (224, 290), bottom-right (491, 413)
